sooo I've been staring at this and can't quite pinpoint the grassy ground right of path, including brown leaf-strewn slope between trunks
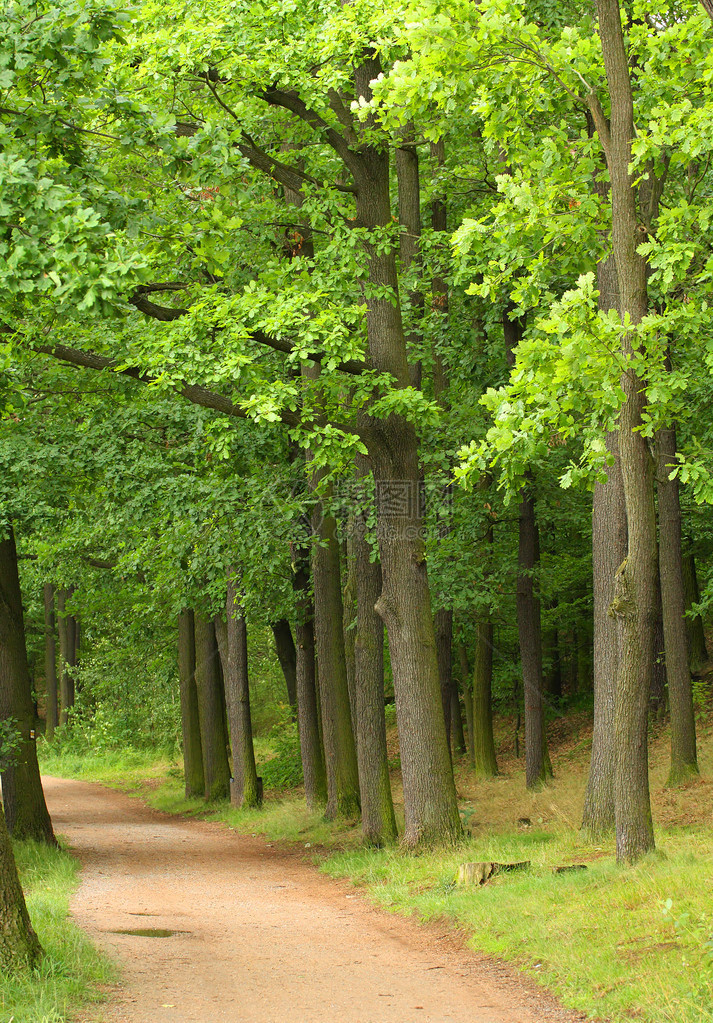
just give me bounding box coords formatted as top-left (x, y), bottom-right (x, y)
top-left (36, 713), bottom-right (713, 1023)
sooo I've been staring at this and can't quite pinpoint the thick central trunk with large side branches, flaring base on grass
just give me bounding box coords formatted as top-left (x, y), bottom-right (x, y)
top-left (349, 65), bottom-right (462, 848)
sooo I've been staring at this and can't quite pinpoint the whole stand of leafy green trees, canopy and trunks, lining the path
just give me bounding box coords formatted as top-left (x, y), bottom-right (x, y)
top-left (0, 0), bottom-right (711, 969)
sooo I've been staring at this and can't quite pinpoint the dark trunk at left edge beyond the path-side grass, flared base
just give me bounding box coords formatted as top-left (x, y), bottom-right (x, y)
top-left (0, 527), bottom-right (56, 845)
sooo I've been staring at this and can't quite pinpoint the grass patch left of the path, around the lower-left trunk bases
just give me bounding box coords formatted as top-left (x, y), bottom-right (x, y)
top-left (0, 842), bottom-right (115, 1023)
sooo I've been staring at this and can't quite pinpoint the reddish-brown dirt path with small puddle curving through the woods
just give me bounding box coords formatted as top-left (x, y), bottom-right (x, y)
top-left (45, 779), bottom-right (581, 1023)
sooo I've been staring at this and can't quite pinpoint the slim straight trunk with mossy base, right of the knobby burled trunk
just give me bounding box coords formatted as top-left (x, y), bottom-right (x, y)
top-left (657, 428), bottom-right (698, 785)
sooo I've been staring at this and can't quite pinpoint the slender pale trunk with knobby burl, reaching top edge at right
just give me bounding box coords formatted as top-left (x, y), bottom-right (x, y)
top-left (588, 0), bottom-right (658, 862)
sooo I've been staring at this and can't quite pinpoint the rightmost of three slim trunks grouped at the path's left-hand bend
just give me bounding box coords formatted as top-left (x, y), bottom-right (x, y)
top-left (225, 567), bottom-right (262, 806)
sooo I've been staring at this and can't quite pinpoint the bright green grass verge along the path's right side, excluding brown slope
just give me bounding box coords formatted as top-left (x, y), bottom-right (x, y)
top-left (37, 744), bottom-right (713, 1023)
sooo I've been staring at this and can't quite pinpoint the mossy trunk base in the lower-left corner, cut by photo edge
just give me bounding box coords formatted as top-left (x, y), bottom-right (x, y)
top-left (0, 806), bottom-right (42, 977)
